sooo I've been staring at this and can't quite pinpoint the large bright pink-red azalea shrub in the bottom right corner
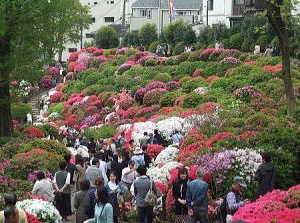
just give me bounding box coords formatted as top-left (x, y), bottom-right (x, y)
top-left (232, 185), bottom-right (300, 223)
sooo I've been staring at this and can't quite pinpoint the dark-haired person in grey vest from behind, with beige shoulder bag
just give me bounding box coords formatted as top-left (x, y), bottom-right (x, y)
top-left (133, 165), bottom-right (156, 223)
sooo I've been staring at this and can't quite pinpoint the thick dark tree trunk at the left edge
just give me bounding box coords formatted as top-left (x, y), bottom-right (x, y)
top-left (0, 35), bottom-right (12, 136)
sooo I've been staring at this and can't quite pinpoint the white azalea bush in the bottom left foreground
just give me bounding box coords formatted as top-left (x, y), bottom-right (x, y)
top-left (16, 199), bottom-right (62, 223)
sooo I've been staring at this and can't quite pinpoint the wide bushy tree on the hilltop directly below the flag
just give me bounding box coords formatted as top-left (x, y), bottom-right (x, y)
top-left (163, 20), bottom-right (196, 46)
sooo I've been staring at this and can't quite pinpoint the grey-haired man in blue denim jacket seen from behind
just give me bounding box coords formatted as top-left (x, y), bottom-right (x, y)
top-left (185, 168), bottom-right (208, 223)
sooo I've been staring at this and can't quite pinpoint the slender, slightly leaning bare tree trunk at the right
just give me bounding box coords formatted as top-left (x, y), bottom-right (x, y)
top-left (267, 0), bottom-right (296, 116)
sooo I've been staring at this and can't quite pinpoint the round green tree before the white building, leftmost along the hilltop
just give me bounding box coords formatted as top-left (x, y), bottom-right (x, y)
top-left (95, 26), bottom-right (119, 49)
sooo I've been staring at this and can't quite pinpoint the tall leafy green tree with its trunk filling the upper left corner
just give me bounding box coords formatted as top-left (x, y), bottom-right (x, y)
top-left (0, 0), bottom-right (91, 136)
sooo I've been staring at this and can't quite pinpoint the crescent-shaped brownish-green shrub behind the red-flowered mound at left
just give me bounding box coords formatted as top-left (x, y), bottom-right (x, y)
top-left (20, 139), bottom-right (68, 155)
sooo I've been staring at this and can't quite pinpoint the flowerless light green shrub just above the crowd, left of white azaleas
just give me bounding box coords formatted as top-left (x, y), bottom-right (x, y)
top-left (83, 125), bottom-right (118, 139)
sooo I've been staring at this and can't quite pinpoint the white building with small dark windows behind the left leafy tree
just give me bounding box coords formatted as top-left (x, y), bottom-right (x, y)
top-left (62, 0), bottom-right (135, 61)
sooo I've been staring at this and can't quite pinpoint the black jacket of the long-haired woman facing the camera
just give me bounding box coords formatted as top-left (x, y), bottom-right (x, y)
top-left (172, 179), bottom-right (188, 215)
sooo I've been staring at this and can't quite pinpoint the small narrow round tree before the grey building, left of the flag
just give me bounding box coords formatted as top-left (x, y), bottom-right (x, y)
top-left (139, 23), bottom-right (158, 48)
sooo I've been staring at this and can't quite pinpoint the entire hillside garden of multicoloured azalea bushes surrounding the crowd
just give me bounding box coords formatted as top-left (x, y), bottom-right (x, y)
top-left (0, 47), bottom-right (300, 223)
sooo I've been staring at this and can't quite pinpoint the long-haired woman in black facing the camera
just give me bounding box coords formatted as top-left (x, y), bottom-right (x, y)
top-left (172, 167), bottom-right (189, 223)
